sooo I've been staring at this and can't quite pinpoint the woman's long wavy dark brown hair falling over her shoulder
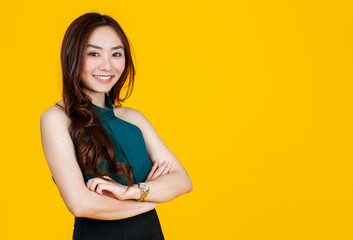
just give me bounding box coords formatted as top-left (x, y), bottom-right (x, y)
top-left (61, 12), bottom-right (135, 186)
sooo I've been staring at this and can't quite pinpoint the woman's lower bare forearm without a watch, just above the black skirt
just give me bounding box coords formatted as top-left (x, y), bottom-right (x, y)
top-left (75, 189), bottom-right (157, 220)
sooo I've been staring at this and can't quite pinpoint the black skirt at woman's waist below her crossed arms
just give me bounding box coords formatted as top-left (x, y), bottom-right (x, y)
top-left (72, 209), bottom-right (164, 240)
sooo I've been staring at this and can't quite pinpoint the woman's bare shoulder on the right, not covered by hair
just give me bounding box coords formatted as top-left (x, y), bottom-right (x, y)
top-left (114, 107), bottom-right (149, 128)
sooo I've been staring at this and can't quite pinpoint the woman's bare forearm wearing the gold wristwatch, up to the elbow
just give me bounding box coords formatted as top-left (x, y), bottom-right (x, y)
top-left (133, 172), bottom-right (192, 203)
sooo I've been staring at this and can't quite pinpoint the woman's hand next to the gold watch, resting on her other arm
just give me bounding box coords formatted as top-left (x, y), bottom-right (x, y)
top-left (86, 176), bottom-right (134, 200)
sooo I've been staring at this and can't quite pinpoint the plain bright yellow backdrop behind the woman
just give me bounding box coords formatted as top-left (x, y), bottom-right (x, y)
top-left (0, 0), bottom-right (353, 240)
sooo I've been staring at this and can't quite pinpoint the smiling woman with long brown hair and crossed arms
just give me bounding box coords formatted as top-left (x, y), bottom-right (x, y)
top-left (41, 13), bottom-right (192, 240)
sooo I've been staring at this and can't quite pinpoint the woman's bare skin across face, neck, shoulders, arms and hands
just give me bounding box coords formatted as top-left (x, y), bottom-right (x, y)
top-left (40, 26), bottom-right (192, 220)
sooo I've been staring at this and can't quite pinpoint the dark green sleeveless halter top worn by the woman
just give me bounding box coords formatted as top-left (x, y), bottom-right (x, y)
top-left (53, 94), bottom-right (152, 185)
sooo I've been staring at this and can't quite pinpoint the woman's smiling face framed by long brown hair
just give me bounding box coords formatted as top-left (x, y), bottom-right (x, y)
top-left (81, 26), bottom-right (125, 95)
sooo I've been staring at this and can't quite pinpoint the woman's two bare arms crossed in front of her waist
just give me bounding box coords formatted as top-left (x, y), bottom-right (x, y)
top-left (41, 107), bottom-right (192, 220)
